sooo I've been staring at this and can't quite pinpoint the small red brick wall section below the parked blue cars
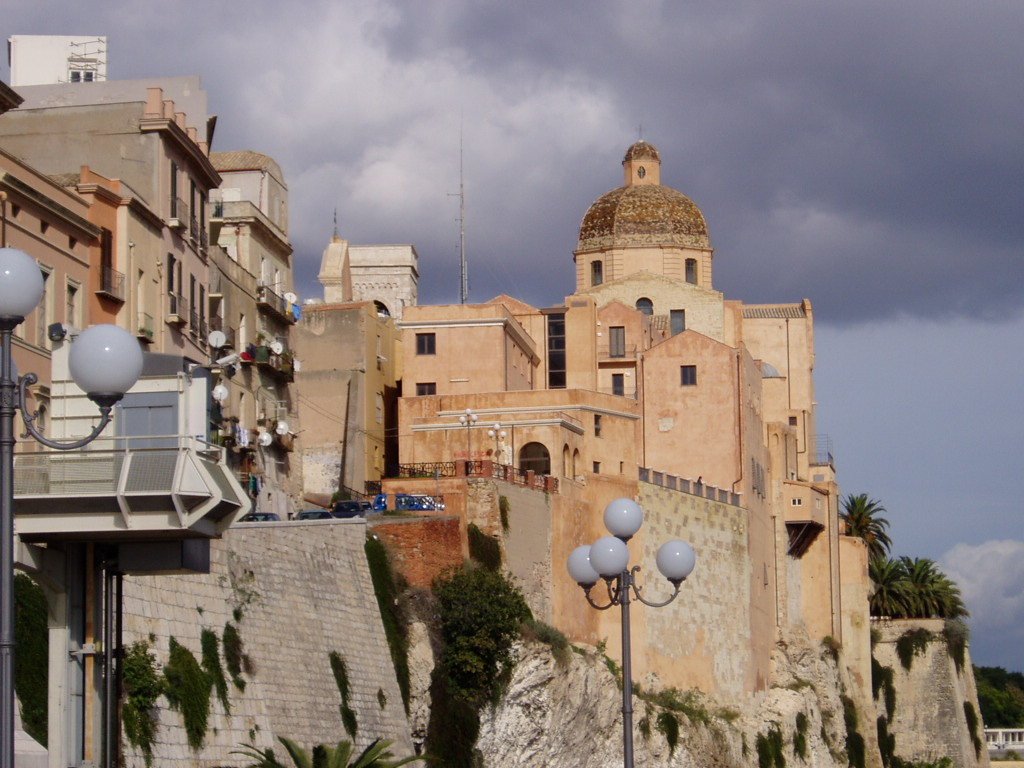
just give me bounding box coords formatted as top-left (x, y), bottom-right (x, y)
top-left (371, 517), bottom-right (463, 589)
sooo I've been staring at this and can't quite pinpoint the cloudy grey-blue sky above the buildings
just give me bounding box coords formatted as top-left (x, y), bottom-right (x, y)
top-left (3, 0), bottom-right (1024, 670)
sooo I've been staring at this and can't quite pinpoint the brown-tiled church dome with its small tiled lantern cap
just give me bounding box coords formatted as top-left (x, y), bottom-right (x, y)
top-left (577, 180), bottom-right (711, 251)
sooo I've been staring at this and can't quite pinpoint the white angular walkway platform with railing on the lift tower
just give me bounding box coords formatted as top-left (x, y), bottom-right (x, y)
top-left (14, 438), bottom-right (252, 543)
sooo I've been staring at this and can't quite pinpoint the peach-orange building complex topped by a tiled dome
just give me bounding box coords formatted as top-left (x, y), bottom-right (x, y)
top-left (398, 141), bottom-right (866, 690)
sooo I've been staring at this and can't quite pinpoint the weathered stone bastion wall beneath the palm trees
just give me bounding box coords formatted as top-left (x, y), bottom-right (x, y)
top-left (873, 618), bottom-right (989, 768)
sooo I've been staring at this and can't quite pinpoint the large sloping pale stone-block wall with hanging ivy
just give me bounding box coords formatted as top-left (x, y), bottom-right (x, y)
top-left (118, 520), bottom-right (412, 768)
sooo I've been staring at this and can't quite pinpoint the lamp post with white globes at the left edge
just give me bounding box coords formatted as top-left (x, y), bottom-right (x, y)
top-left (0, 248), bottom-right (142, 768)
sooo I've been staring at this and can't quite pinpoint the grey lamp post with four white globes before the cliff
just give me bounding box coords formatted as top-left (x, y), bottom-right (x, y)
top-left (567, 499), bottom-right (696, 768)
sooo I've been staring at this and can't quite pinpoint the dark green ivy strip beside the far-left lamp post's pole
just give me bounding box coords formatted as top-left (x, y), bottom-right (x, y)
top-left (14, 573), bottom-right (50, 744)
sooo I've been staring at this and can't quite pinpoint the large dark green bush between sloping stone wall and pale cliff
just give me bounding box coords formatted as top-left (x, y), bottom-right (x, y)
top-left (427, 565), bottom-right (531, 768)
